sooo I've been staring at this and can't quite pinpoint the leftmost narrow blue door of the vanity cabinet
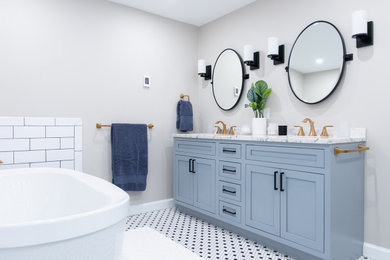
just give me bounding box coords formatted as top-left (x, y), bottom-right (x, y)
top-left (175, 155), bottom-right (194, 205)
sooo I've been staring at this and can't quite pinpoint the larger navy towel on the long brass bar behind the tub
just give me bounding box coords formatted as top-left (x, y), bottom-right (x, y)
top-left (111, 124), bottom-right (148, 191)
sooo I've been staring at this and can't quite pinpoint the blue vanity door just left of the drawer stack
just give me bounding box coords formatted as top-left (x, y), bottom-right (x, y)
top-left (194, 158), bottom-right (217, 213)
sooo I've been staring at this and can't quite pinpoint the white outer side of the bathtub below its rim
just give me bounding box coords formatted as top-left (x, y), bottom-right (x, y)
top-left (0, 220), bottom-right (125, 260)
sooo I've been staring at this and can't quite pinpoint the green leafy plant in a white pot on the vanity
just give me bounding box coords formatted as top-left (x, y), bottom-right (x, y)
top-left (245, 80), bottom-right (272, 135)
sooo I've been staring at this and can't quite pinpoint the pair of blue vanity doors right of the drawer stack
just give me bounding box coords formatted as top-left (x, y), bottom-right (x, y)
top-left (245, 165), bottom-right (325, 252)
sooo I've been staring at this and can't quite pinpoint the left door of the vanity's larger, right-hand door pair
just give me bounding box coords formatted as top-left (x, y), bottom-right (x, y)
top-left (245, 165), bottom-right (280, 236)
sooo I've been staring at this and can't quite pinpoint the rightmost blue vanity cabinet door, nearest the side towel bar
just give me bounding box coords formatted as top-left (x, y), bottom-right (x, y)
top-left (281, 170), bottom-right (324, 252)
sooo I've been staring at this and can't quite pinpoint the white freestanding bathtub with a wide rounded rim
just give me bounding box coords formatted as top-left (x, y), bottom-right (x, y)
top-left (0, 168), bottom-right (129, 260)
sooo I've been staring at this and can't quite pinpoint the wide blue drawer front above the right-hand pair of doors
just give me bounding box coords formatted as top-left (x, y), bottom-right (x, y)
top-left (246, 145), bottom-right (325, 168)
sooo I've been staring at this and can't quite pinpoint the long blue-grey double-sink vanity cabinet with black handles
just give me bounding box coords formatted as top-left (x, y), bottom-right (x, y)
top-left (174, 137), bottom-right (364, 260)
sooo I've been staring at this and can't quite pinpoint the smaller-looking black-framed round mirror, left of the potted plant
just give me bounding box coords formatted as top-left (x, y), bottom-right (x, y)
top-left (213, 49), bottom-right (245, 110)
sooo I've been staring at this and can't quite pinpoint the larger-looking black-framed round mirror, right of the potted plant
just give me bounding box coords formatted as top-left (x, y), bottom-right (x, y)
top-left (288, 21), bottom-right (345, 104)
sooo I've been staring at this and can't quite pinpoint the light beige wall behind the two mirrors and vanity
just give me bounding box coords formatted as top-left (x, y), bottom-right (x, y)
top-left (198, 0), bottom-right (390, 248)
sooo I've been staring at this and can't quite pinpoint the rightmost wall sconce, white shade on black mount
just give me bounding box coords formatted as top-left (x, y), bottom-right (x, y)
top-left (352, 10), bottom-right (374, 48)
